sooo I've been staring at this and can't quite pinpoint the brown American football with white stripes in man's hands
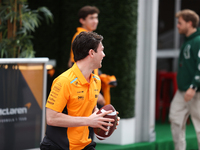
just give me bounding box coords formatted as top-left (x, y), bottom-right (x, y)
top-left (94, 104), bottom-right (118, 140)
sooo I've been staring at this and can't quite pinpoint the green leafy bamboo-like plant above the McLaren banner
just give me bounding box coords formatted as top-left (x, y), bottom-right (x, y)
top-left (0, 0), bottom-right (53, 58)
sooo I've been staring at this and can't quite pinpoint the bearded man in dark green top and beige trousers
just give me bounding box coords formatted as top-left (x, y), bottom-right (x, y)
top-left (169, 9), bottom-right (200, 150)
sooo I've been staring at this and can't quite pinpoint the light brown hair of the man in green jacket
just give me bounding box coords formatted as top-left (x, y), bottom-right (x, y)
top-left (176, 9), bottom-right (199, 28)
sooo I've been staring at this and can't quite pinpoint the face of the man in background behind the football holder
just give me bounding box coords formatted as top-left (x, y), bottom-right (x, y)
top-left (81, 13), bottom-right (99, 31)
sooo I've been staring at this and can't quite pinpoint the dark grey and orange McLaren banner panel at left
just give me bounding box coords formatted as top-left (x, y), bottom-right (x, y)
top-left (0, 64), bottom-right (44, 150)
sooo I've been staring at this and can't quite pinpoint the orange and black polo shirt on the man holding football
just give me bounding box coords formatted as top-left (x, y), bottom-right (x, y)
top-left (46, 63), bottom-right (101, 150)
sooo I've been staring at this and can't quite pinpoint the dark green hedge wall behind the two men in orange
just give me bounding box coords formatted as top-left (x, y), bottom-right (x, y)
top-left (29, 0), bottom-right (138, 118)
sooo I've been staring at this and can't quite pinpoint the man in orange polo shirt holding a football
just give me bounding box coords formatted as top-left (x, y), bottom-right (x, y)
top-left (40, 32), bottom-right (117, 150)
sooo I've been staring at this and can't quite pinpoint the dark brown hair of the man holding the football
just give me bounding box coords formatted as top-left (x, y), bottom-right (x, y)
top-left (72, 32), bottom-right (103, 62)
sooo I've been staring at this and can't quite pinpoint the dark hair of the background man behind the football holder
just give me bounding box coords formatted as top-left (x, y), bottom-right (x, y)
top-left (78, 6), bottom-right (99, 19)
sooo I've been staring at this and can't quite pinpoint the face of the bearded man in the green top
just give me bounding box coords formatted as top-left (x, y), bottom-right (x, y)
top-left (177, 17), bottom-right (190, 34)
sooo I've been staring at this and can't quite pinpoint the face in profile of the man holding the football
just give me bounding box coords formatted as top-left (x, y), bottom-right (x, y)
top-left (94, 42), bottom-right (105, 68)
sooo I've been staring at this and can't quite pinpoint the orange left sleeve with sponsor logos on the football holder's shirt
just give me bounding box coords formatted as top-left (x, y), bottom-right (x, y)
top-left (46, 77), bottom-right (69, 112)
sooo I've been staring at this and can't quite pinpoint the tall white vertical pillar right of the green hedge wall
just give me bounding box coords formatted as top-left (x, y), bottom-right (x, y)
top-left (135, 0), bottom-right (158, 142)
